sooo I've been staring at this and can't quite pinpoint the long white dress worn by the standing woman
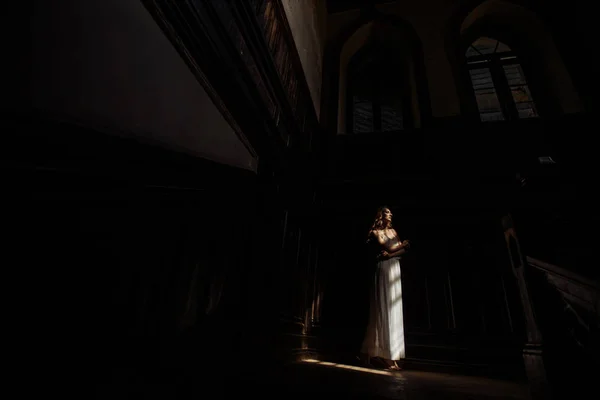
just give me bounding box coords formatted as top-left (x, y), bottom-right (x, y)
top-left (362, 238), bottom-right (406, 360)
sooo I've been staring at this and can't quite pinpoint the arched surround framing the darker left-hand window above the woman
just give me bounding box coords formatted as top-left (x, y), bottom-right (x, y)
top-left (322, 10), bottom-right (431, 135)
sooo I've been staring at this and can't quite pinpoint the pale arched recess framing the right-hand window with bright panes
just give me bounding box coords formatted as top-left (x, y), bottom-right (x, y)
top-left (446, 0), bottom-right (582, 116)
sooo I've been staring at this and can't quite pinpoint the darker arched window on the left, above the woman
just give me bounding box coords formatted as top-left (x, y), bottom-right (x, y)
top-left (346, 46), bottom-right (412, 133)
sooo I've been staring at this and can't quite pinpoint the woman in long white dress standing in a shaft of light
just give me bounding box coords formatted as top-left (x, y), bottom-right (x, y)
top-left (361, 207), bottom-right (410, 370)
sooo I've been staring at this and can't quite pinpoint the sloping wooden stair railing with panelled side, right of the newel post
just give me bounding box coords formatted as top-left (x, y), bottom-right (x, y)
top-left (524, 257), bottom-right (600, 398)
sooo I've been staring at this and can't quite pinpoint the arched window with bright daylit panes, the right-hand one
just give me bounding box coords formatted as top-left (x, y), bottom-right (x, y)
top-left (465, 37), bottom-right (538, 122)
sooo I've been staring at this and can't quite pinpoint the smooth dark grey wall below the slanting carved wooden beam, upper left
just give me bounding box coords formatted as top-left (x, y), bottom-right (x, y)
top-left (24, 0), bottom-right (257, 171)
